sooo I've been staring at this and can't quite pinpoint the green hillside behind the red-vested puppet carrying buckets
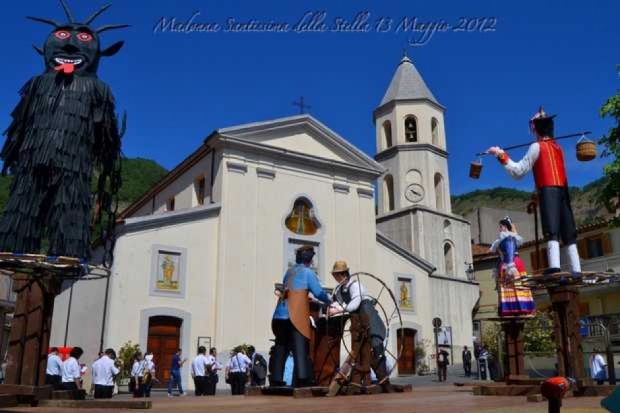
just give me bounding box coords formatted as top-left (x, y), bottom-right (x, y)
top-left (452, 178), bottom-right (611, 225)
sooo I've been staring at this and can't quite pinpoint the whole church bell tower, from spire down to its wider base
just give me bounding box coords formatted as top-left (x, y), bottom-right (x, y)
top-left (373, 56), bottom-right (471, 279)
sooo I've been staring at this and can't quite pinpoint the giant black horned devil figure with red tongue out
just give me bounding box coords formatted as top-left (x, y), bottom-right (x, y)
top-left (0, 0), bottom-right (127, 260)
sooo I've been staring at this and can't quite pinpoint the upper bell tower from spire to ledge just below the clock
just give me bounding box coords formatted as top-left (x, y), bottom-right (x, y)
top-left (373, 56), bottom-right (452, 215)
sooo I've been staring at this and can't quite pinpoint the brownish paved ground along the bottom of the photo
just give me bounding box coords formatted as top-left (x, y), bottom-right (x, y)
top-left (1, 367), bottom-right (607, 413)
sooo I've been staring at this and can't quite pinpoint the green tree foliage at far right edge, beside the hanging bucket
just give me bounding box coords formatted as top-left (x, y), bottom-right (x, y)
top-left (598, 91), bottom-right (620, 226)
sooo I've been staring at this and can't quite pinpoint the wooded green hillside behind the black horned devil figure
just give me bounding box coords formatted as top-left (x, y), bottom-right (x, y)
top-left (0, 158), bottom-right (168, 216)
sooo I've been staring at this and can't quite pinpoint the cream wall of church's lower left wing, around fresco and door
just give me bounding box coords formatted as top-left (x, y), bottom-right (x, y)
top-left (105, 213), bottom-right (219, 388)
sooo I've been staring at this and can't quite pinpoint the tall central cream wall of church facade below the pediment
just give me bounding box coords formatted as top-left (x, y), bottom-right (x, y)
top-left (218, 149), bottom-right (376, 353)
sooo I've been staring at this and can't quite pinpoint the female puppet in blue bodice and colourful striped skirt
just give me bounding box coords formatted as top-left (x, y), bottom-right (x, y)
top-left (491, 217), bottom-right (534, 317)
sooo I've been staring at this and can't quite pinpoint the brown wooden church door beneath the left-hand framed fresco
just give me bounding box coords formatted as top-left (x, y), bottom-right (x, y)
top-left (146, 316), bottom-right (183, 387)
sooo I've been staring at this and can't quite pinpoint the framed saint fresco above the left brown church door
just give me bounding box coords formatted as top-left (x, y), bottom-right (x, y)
top-left (151, 245), bottom-right (187, 298)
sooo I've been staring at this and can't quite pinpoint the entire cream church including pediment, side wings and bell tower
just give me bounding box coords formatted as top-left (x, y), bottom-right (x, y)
top-left (50, 54), bottom-right (479, 388)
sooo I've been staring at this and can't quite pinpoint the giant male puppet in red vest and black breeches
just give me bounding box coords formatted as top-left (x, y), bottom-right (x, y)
top-left (487, 107), bottom-right (581, 274)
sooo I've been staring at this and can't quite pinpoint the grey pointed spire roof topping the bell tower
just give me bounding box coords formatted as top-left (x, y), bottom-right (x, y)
top-left (381, 56), bottom-right (441, 106)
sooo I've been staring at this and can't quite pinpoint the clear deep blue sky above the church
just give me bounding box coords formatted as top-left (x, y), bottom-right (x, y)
top-left (0, 0), bottom-right (620, 194)
